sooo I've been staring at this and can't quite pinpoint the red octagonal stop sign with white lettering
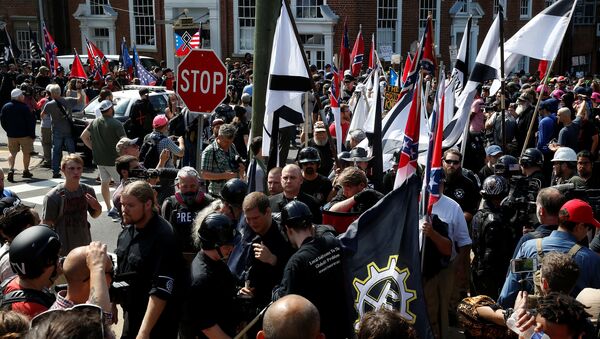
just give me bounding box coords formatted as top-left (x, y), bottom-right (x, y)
top-left (177, 49), bottom-right (227, 112)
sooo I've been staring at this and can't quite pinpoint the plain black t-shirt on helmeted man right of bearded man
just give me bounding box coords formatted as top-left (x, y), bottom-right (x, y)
top-left (182, 251), bottom-right (237, 338)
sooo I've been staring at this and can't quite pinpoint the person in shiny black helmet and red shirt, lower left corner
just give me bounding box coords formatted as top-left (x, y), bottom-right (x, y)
top-left (0, 226), bottom-right (60, 318)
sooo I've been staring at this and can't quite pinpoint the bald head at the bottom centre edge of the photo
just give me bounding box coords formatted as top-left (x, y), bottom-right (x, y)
top-left (257, 294), bottom-right (323, 339)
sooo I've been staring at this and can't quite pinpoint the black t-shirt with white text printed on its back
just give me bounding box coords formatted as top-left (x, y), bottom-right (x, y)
top-left (274, 235), bottom-right (351, 338)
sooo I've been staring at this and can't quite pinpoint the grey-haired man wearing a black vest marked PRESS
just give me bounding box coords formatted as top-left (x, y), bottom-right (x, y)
top-left (161, 166), bottom-right (215, 252)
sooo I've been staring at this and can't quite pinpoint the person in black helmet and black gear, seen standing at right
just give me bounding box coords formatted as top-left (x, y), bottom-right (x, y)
top-left (471, 175), bottom-right (521, 299)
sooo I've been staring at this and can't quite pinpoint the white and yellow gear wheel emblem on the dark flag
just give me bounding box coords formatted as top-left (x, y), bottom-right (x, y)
top-left (352, 255), bottom-right (417, 330)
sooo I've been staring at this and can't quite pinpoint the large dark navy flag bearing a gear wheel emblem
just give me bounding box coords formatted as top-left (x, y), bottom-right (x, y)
top-left (340, 176), bottom-right (433, 338)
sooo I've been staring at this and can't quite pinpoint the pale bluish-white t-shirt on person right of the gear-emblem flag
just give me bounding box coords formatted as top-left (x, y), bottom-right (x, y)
top-left (431, 195), bottom-right (472, 260)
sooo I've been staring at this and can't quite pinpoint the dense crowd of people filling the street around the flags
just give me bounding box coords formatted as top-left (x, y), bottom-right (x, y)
top-left (0, 51), bottom-right (600, 338)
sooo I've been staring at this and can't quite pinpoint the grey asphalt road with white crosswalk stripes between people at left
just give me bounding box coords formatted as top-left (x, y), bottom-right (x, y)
top-left (0, 122), bottom-right (121, 252)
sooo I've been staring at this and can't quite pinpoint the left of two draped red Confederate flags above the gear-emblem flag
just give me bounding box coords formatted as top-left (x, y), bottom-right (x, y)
top-left (394, 73), bottom-right (421, 188)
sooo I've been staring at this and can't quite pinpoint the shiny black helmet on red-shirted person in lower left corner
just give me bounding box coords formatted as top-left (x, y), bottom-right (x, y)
top-left (9, 226), bottom-right (60, 279)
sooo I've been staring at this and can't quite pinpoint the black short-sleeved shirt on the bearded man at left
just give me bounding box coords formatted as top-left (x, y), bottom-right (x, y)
top-left (115, 213), bottom-right (187, 338)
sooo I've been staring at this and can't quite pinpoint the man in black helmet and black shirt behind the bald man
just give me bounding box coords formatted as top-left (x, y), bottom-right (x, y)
top-left (298, 147), bottom-right (331, 206)
